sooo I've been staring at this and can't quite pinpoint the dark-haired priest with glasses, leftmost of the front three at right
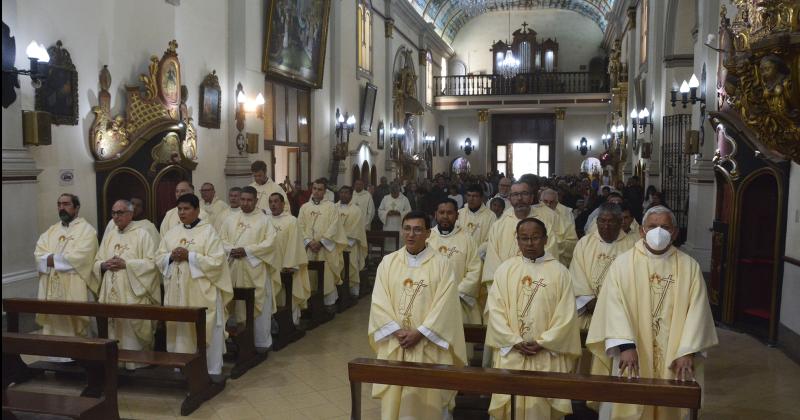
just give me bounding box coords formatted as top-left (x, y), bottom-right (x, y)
top-left (368, 211), bottom-right (466, 420)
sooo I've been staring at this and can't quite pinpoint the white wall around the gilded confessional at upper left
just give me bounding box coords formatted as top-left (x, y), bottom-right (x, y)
top-left (8, 0), bottom-right (230, 231)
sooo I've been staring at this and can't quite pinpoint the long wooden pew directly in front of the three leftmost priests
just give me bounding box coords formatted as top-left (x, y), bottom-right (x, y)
top-left (3, 298), bottom-right (225, 416)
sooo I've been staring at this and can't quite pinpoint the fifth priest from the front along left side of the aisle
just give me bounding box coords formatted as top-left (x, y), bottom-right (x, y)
top-left (336, 186), bottom-right (367, 296)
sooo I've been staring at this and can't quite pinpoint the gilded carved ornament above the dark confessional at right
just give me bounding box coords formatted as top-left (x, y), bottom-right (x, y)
top-left (718, 0), bottom-right (800, 163)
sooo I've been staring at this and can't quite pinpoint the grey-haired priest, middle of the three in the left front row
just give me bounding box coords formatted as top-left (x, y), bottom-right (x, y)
top-left (92, 200), bottom-right (161, 369)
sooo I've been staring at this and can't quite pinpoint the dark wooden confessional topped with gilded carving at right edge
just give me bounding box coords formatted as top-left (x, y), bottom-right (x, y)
top-left (709, 0), bottom-right (800, 342)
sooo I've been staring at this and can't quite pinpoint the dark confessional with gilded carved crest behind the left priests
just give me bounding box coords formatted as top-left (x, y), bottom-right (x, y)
top-left (89, 40), bottom-right (197, 224)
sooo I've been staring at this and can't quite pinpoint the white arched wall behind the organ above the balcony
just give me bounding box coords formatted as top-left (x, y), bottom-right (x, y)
top-left (452, 9), bottom-right (606, 74)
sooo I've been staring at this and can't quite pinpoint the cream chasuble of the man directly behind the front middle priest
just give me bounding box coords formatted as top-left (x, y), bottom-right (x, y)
top-left (482, 206), bottom-right (560, 283)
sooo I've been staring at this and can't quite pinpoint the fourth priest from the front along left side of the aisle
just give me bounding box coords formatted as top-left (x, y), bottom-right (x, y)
top-left (297, 180), bottom-right (347, 306)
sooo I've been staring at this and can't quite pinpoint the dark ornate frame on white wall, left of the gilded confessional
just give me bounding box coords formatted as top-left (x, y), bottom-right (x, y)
top-left (34, 40), bottom-right (78, 125)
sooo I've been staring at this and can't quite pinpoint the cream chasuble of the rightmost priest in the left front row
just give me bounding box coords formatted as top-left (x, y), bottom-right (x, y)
top-left (156, 220), bottom-right (233, 353)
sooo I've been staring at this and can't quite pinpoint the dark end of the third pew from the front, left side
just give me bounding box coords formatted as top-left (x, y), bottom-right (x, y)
top-left (225, 287), bottom-right (267, 379)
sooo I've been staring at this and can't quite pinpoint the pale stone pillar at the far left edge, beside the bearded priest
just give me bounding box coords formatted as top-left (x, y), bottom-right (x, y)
top-left (2, 1), bottom-right (43, 297)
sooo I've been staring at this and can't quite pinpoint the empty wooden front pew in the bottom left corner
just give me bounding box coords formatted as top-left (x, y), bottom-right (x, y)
top-left (3, 332), bottom-right (119, 420)
